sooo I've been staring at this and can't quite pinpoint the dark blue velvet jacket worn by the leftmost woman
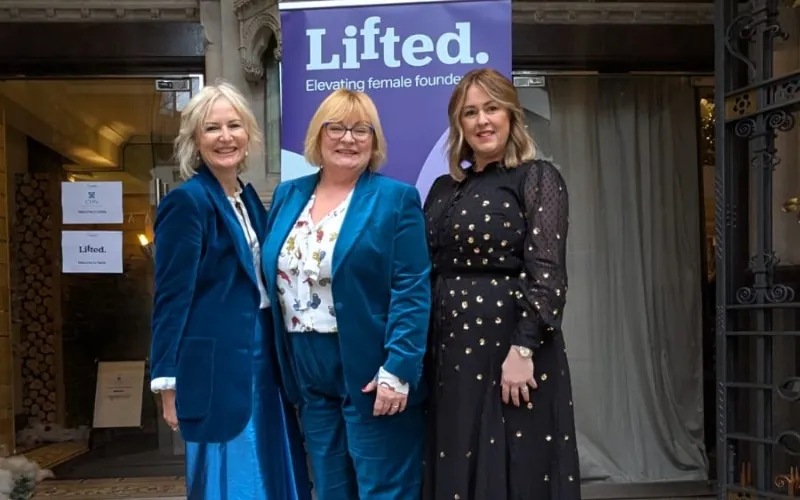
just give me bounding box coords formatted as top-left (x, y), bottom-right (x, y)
top-left (150, 167), bottom-right (267, 442)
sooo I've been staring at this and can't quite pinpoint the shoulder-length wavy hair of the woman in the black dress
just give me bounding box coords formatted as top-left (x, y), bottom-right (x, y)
top-left (447, 68), bottom-right (536, 182)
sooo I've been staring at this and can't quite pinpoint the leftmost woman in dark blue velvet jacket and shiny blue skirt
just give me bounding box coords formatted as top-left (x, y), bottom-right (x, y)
top-left (151, 84), bottom-right (311, 500)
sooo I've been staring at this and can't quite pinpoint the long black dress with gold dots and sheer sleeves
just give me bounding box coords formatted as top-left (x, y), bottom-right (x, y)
top-left (423, 161), bottom-right (580, 500)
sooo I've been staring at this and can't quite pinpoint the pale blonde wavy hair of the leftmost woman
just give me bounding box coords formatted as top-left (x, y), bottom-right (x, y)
top-left (174, 81), bottom-right (264, 179)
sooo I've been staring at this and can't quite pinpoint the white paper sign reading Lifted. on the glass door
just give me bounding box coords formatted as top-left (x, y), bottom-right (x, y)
top-left (61, 231), bottom-right (122, 274)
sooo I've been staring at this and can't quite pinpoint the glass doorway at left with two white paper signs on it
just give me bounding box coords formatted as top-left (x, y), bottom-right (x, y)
top-left (0, 75), bottom-right (203, 479)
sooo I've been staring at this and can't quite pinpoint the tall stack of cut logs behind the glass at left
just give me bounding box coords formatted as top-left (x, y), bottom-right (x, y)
top-left (12, 173), bottom-right (59, 423)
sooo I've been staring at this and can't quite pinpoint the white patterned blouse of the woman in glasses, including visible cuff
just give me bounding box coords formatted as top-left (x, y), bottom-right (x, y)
top-left (277, 192), bottom-right (409, 394)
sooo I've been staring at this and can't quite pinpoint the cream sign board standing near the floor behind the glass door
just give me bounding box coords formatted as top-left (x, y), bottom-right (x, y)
top-left (93, 361), bottom-right (145, 428)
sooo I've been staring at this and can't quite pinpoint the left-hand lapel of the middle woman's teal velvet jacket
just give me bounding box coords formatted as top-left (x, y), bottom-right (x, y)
top-left (261, 177), bottom-right (316, 292)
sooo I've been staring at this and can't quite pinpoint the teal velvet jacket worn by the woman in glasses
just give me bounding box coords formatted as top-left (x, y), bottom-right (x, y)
top-left (262, 172), bottom-right (431, 414)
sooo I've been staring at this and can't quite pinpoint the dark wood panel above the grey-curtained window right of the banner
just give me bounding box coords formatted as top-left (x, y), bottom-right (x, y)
top-left (512, 24), bottom-right (714, 73)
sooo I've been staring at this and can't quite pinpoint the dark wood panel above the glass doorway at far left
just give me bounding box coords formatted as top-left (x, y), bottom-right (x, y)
top-left (0, 22), bottom-right (205, 77)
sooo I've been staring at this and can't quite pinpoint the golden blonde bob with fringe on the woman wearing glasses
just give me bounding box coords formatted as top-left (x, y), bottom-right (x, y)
top-left (304, 89), bottom-right (386, 172)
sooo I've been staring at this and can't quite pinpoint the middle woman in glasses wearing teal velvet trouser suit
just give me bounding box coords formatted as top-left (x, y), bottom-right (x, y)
top-left (262, 90), bottom-right (431, 500)
